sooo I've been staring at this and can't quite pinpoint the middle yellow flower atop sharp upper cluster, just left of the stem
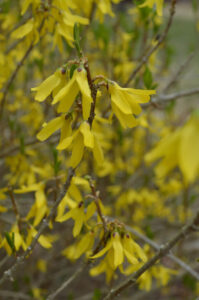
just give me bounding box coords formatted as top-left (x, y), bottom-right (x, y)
top-left (52, 68), bottom-right (92, 120)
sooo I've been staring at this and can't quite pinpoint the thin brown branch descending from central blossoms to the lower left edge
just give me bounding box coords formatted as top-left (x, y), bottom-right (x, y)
top-left (0, 168), bottom-right (75, 285)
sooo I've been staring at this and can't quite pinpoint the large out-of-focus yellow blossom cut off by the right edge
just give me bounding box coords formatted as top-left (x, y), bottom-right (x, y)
top-left (145, 116), bottom-right (199, 182)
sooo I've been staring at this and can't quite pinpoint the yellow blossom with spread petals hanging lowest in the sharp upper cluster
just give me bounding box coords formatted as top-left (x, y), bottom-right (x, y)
top-left (57, 122), bottom-right (103, 168)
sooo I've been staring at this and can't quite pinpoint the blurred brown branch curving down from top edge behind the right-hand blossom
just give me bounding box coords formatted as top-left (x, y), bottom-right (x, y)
top-left (124, 0), bottom-right (177, 86)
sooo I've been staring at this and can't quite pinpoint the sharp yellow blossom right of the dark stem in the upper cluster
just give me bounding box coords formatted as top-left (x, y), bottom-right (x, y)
top-left (108, 81), bottom-right (155, 128)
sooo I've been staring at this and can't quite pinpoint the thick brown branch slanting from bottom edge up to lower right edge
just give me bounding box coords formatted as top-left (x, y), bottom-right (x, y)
top-left (103, 212), bottom-right (199, 300)
